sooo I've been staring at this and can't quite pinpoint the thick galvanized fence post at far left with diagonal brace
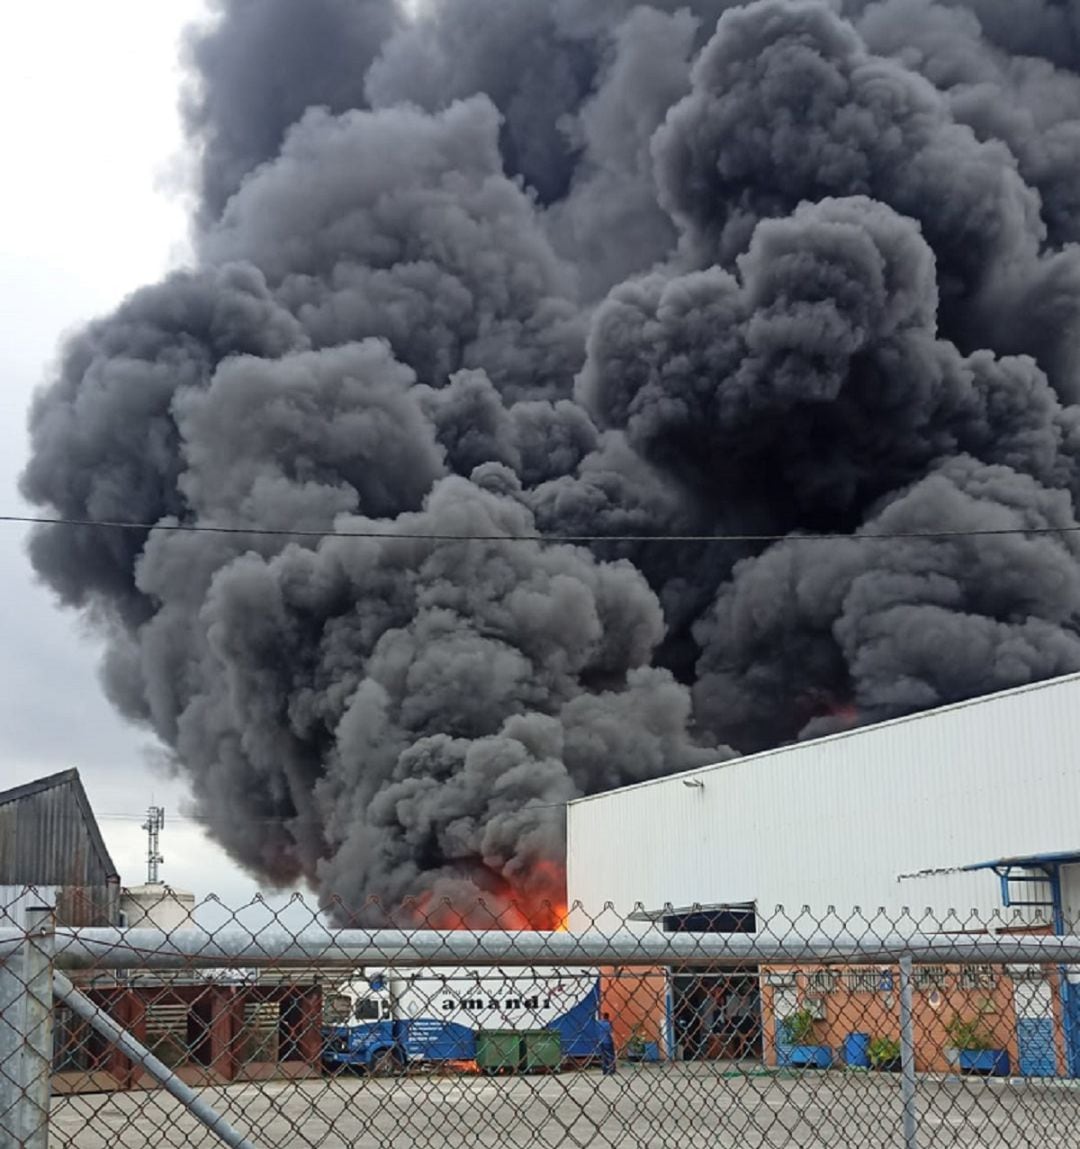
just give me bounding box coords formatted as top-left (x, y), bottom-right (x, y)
top-left (0, 907), bottom-right (54, 1149)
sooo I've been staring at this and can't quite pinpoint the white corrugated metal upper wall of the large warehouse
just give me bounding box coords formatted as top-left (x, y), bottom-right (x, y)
top-left (568, 674), bottom-right (1080, 918)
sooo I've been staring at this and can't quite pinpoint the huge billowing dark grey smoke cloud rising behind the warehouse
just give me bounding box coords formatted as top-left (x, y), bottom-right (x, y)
top-left (23, 0), bottom-right (1080, 924)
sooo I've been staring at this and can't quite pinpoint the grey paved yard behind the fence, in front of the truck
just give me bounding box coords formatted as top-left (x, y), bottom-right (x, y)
top-left (49, 1064), bottom-right (1080, 1149)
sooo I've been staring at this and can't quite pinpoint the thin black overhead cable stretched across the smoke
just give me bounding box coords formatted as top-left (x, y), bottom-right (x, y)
top-left (0, 515), bottom-right (1080, 545)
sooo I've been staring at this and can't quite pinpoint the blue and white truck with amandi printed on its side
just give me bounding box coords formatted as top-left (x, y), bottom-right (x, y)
top-left (323, 967), bottom-right (611, 1073)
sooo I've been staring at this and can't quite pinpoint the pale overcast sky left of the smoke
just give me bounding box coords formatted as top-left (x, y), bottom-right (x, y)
top-left (0, 0), bottom-right (307, 905)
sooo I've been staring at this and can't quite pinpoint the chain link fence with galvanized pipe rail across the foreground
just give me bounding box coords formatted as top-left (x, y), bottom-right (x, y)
top-left (0, 890), bottom-right (1080, 1149)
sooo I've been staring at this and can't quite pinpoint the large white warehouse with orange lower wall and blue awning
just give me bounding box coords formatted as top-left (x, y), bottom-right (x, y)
top-left (566, 674), bottom-right (1080, 1075)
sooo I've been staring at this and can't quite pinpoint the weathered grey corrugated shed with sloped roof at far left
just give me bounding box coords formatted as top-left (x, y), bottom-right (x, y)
top-left (0, 770), bottom-right (119, 925)
